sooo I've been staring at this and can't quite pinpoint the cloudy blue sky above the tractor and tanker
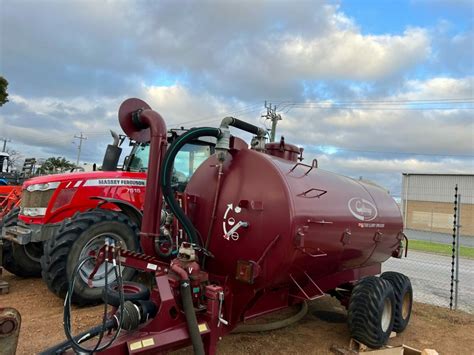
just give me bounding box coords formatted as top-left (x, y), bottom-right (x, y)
top-left (0, 0), bottom-right (474, 194)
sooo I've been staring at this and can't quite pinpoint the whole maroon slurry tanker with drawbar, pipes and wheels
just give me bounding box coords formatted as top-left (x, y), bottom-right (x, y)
top-left (43, 99), bottom-right (412, 354)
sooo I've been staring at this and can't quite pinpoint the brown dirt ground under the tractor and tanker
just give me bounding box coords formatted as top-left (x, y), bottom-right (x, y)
top-left (0, 271), bottom-right (474, 355)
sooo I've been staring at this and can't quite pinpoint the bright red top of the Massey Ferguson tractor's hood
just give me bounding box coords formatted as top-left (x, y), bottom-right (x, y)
top-left (23, 171), bottom-right (146, 189)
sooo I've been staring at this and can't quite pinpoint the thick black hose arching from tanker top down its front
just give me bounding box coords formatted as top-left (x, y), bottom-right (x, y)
top-left (160, 127), bottom-right (221, 246)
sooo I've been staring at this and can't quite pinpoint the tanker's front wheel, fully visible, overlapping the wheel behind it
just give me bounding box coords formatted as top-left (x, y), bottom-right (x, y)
top-left (347, 276), bottom-right (396, 349)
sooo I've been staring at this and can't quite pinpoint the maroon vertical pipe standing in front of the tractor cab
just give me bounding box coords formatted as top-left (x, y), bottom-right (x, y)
top-left (132, 109), bottom-right (168, 255)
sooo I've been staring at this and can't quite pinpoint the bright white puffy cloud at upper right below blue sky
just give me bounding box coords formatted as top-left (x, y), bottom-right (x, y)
top-left (280, 29), bottom-right (430, 80)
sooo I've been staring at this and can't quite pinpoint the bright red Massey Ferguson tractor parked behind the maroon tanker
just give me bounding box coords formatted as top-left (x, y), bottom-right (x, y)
top-left (2, 130), bottom-right (212, 304)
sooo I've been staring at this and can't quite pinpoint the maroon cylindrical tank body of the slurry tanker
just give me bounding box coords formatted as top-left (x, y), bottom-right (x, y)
top-left (186, 139), bottom-right (403, 314)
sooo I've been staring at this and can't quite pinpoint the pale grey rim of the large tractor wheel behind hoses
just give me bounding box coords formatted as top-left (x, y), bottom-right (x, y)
top-left (79, 233), bottom-right (125, 287)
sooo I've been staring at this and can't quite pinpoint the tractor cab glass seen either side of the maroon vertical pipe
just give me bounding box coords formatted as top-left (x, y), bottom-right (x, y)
top-left (127, 144), bottom-right (211, 183)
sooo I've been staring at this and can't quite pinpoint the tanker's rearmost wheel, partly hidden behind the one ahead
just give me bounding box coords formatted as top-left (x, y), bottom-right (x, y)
top-left (380, 271), bottom-right (413, 333)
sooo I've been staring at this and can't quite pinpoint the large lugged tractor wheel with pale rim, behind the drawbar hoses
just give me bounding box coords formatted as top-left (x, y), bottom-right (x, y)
top-left (41, 209), bottom-right (140, 305)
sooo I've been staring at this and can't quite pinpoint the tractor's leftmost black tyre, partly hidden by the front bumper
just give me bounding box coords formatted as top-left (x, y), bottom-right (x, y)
top-left (0, 207), bottom-right (43, 277)
